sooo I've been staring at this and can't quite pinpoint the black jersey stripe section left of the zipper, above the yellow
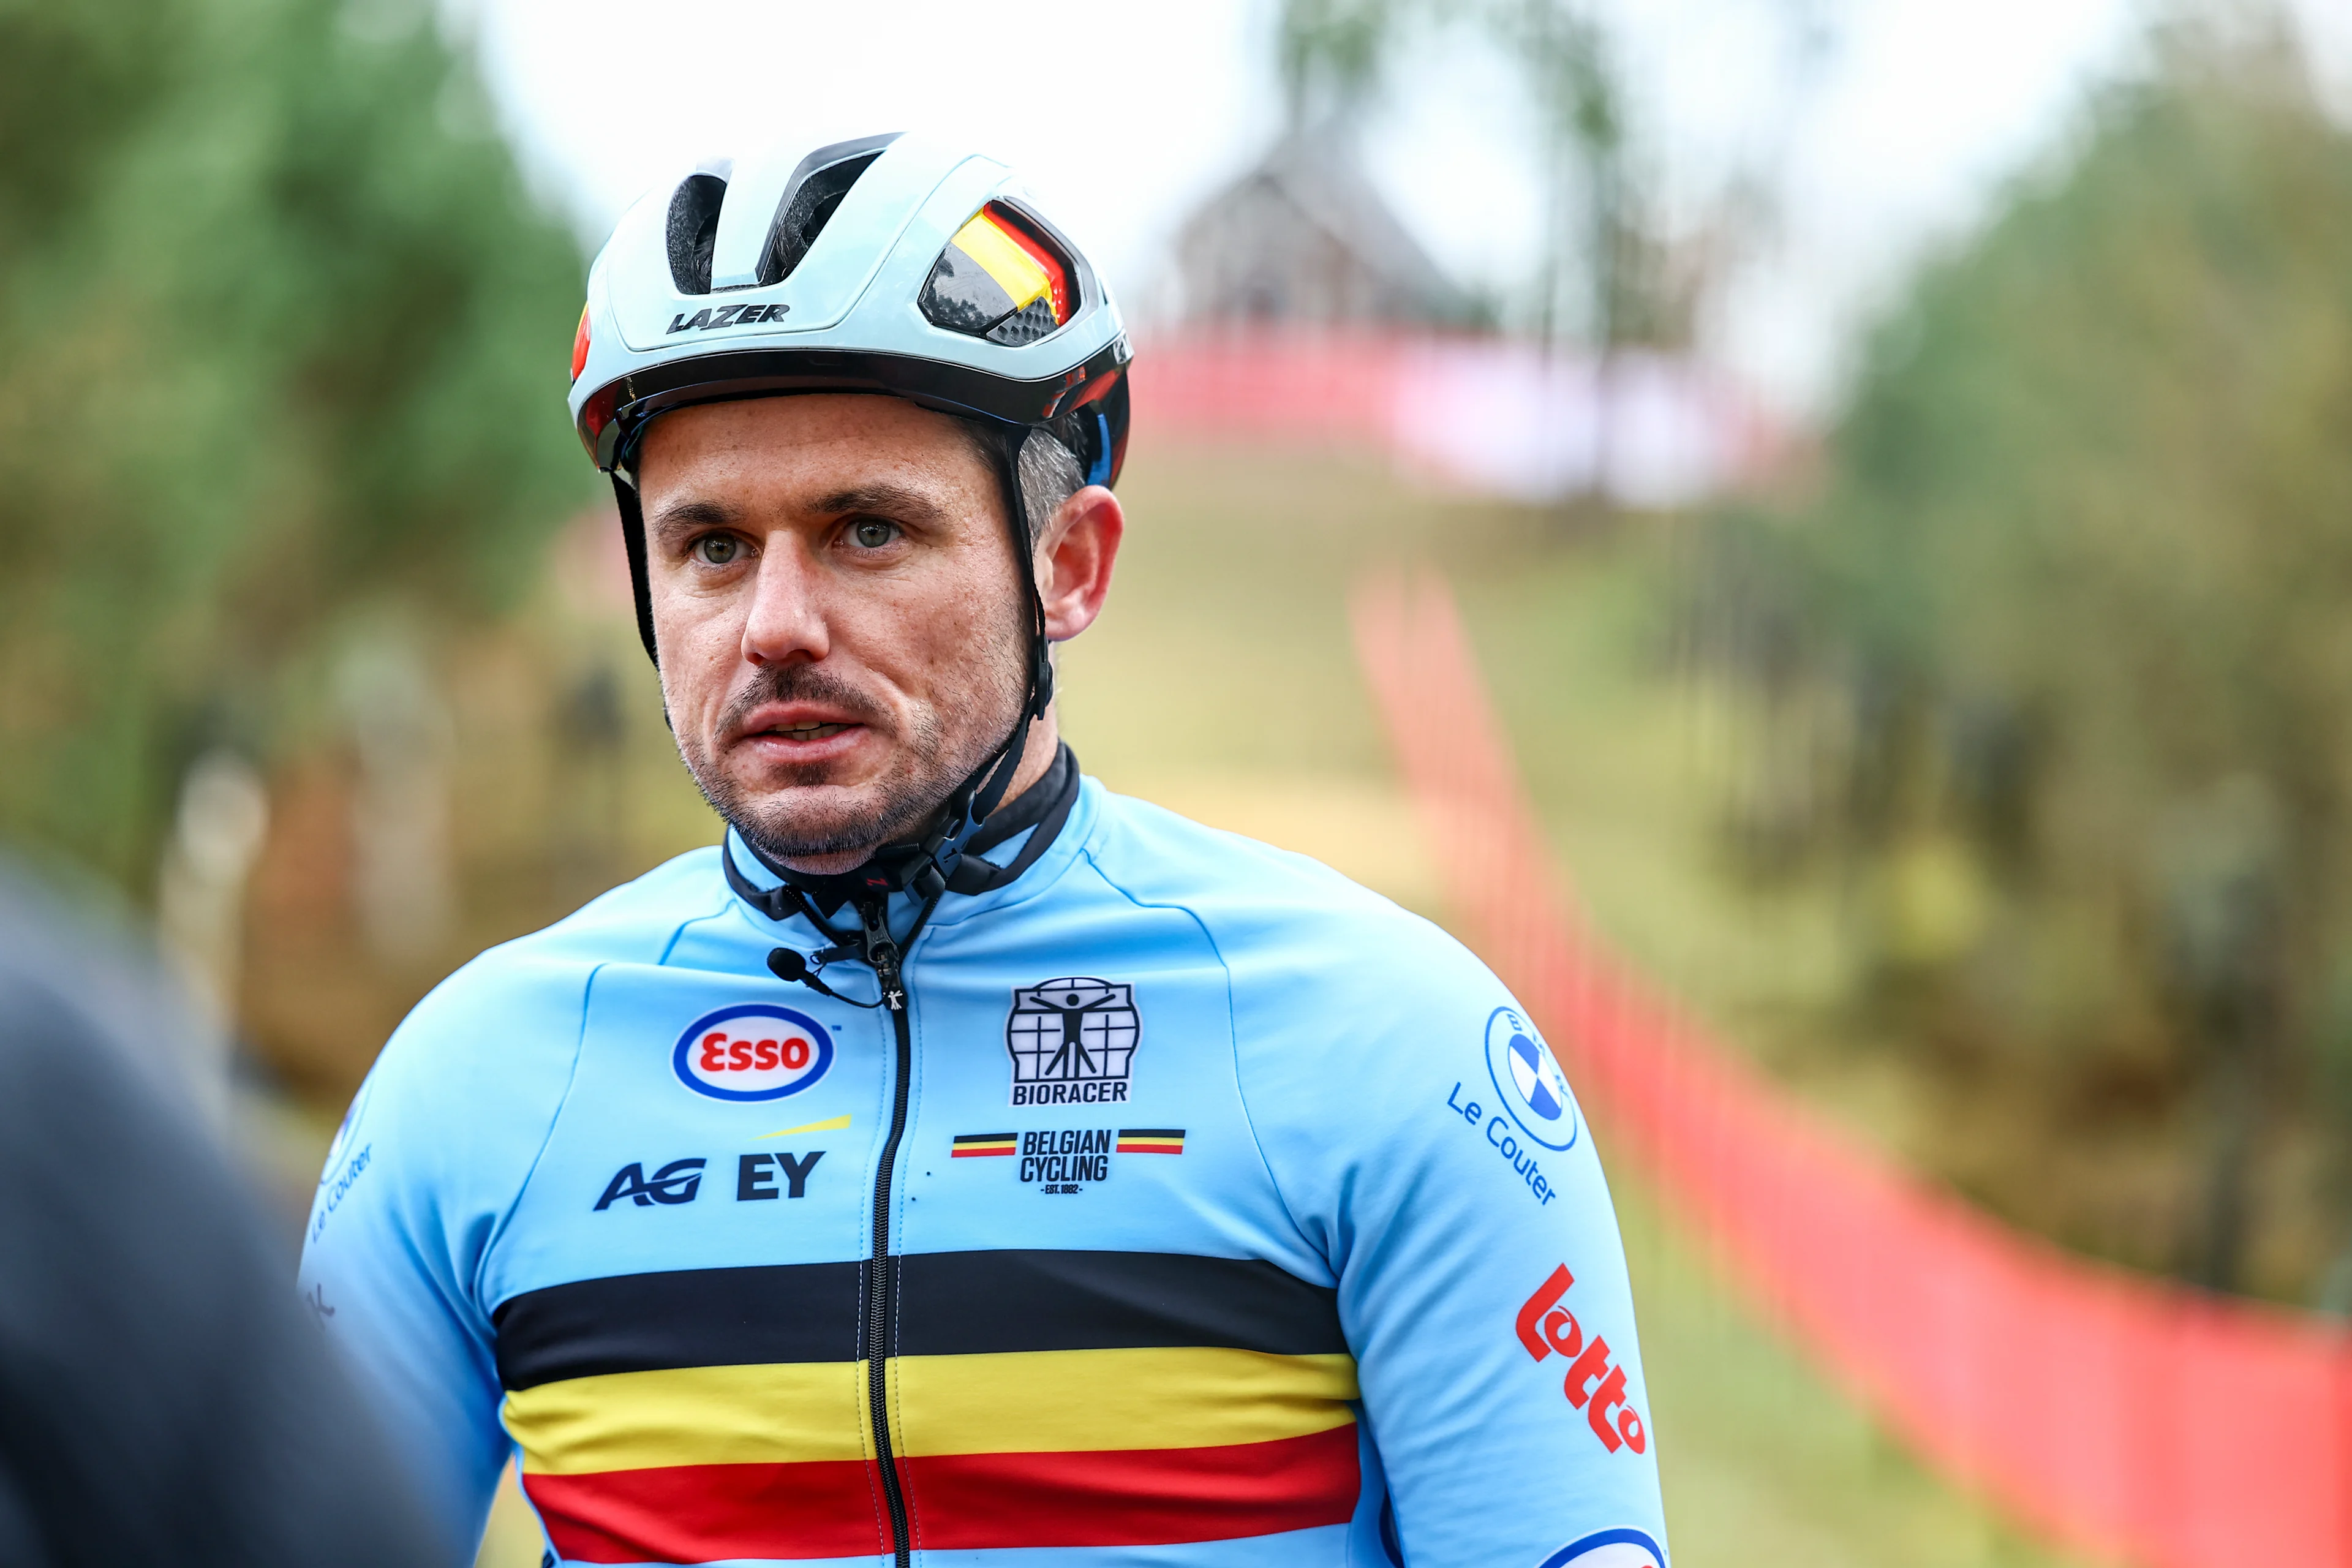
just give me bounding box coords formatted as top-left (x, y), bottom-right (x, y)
top-left (492, 1262), bottom-right (865, 1389)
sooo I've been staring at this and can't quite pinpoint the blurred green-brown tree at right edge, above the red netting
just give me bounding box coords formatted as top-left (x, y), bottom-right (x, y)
top-left (1749, 23), bottom-right (2352, 1286)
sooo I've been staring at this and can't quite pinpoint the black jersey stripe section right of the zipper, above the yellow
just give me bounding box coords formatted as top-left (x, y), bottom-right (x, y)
top-left (899, 1251), bottom-right (1348, 1357)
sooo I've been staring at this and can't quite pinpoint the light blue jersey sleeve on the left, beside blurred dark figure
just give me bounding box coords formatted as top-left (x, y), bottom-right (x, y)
top-left (301, 950), bottom-right (583, 1568)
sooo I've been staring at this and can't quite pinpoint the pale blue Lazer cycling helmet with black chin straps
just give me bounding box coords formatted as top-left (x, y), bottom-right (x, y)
top-left (571, 134), bottom-right (1134, 907)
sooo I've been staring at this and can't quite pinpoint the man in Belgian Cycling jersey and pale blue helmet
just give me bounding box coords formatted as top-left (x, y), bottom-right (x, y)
top-left (306, 137), bottom-right (1663, 1568)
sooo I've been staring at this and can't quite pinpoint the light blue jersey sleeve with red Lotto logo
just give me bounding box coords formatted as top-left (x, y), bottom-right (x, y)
top-left (1235, 910), bottom-right (1665, 1568)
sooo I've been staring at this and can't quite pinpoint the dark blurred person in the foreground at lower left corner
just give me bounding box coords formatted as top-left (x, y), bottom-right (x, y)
top-left (0, 865), bottom-right (435, 1568)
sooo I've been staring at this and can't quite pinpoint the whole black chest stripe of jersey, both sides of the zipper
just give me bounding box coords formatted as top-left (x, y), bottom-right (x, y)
top-left (492, 1251), bottom-right (1348, 1389)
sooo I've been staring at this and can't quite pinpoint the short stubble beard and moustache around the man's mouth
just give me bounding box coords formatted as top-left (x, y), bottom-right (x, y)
top-left (677, 637), bottom-right (1021, 863)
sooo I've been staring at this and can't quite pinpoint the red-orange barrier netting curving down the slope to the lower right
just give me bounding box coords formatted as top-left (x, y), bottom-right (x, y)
top-left (1355, 573), bottom-right (2352, 1568)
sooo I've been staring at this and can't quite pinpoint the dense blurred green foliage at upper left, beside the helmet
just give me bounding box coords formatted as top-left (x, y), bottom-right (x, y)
top-left (0, 0), bottom-right (588, 889)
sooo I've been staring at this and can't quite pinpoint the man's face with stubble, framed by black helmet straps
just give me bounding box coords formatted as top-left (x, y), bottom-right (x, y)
top-left (638, 395), bottom-right (1028, 872)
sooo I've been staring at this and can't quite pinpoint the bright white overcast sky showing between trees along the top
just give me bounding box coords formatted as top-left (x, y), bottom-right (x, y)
top-left (447, 0), bottom-right (2347, 409)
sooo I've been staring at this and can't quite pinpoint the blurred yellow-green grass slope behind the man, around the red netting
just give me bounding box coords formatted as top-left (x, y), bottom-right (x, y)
top-left (468, 439), bottom-right (2067, 1568)
